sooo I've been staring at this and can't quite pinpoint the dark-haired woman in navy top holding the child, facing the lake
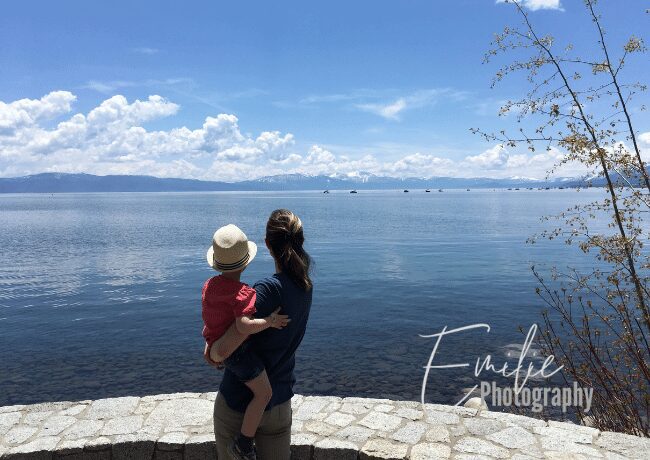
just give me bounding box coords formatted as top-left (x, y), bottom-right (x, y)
top-left (206, 209), bottom-right (312, 460)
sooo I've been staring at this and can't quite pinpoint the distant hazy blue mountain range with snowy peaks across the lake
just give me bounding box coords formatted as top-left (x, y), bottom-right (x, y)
top-left (0, 173), bottom-right (602, 193)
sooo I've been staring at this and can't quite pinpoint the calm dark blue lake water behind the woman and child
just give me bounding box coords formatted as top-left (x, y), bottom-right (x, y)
top-left (0, 190), bottom-right (603, 405)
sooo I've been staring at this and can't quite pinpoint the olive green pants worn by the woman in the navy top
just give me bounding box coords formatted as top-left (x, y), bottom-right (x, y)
top-left (214, 394), bottom-right (291, 460)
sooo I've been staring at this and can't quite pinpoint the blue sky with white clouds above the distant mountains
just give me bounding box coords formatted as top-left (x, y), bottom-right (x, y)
top-left (0, 0), bottom-right (650, 180)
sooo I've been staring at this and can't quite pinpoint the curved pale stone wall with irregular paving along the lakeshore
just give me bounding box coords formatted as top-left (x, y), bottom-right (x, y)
top-left (0, 393), bottom-right (650, 460)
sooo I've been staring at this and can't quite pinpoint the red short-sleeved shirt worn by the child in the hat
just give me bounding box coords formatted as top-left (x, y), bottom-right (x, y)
top-left (201, 275), bottom-right (256, 346)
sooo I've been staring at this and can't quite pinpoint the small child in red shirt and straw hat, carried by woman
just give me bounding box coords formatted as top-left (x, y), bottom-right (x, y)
top-left (201, 224), bottom-right (289, 460)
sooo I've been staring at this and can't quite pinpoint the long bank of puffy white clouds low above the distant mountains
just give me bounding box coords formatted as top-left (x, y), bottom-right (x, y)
top-left (0, 91), bottom-right (596, 181)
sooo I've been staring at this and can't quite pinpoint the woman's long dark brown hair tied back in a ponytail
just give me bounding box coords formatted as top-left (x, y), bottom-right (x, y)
top-left (266, 209), bottom-right (312, 291)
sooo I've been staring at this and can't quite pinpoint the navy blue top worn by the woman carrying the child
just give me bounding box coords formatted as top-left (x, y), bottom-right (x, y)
top-left (219, 273), bottom-right (313, 412)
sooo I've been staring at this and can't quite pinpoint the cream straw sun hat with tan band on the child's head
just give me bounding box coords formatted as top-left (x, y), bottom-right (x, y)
top-left (206, 224), bottom-right (257, 272)
